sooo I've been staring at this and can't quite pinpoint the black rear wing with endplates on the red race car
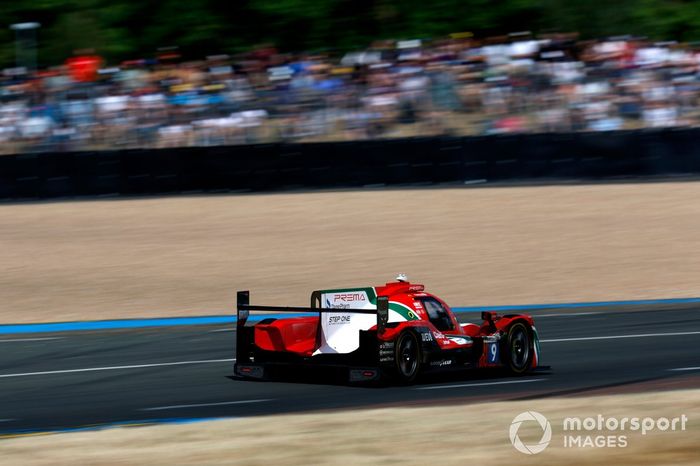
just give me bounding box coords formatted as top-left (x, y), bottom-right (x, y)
top-left (236, 291), bottom-right (389, 361)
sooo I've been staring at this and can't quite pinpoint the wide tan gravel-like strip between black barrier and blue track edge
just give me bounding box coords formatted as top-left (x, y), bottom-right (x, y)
top-left (0, 182), bottom-right (700, 323)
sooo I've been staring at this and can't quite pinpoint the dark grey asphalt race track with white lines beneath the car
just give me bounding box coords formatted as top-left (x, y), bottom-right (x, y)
top-left (0, 305), bottom-right (700, 437)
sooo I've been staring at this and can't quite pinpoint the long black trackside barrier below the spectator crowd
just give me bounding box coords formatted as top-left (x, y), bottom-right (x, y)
top-left (0, 129), bottom-right (700, 199)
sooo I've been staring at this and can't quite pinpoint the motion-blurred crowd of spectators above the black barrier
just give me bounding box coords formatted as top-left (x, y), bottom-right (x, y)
top-left (0, 33), bottom-right (700, 153)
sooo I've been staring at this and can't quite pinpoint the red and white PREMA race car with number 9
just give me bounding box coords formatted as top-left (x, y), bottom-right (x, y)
top-left (234, 275), bottom-right (539, 383)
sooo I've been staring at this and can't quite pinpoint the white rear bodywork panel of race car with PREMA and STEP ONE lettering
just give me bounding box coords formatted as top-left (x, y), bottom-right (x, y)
top-left (314, 290), bottom-right (377, 355)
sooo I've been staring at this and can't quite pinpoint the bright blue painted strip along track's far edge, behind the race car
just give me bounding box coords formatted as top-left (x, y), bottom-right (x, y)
top-left (0, 298), bottom-right (700, 335)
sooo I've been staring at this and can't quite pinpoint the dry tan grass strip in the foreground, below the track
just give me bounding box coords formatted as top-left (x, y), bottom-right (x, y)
top-left (0, 390), bottom-right (700, 466)
